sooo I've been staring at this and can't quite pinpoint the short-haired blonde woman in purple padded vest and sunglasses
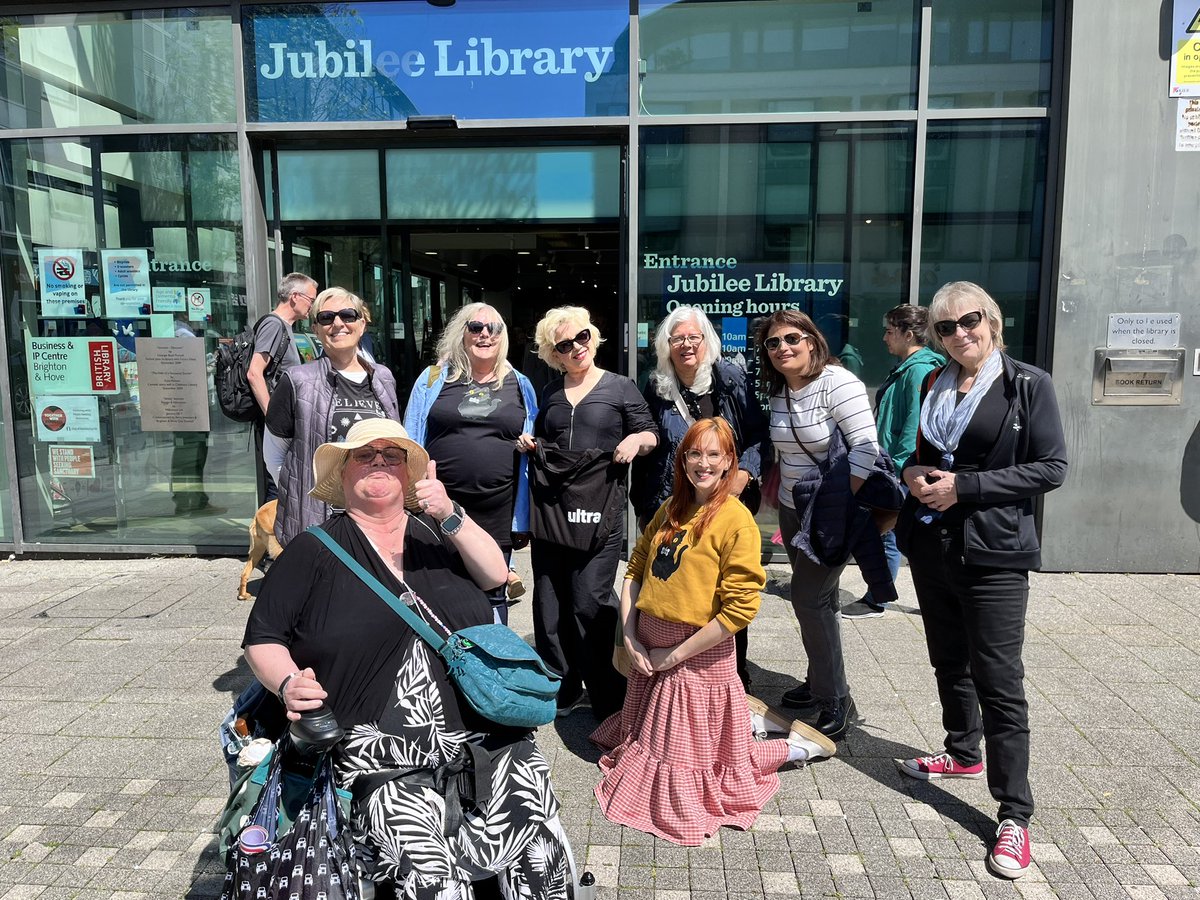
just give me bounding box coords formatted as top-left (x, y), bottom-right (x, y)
top-left (263, 287), bottom-right (400, 546)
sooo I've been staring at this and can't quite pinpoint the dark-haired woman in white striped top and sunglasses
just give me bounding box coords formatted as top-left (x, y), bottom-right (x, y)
top-left (756, 310), bottom-right (880, 740)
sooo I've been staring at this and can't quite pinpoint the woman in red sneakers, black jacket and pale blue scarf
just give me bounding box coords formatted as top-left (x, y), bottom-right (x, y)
top-left (896, 281), bottom-right (1067, 878)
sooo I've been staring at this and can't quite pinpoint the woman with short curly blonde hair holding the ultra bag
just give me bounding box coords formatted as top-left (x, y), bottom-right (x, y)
top-left (518, 306), bottom-right (658, 719)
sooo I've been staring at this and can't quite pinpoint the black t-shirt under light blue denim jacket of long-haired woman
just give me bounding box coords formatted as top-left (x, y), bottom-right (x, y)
top-left (425, 374), bottom-right (526, 551)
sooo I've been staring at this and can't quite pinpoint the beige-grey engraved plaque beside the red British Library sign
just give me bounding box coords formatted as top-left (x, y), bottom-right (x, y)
top-left (137, 337), bottom-right (209, 431)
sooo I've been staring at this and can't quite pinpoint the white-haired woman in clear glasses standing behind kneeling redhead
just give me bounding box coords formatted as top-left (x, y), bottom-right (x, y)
top-left (629, 306), bottom-right (770, 690)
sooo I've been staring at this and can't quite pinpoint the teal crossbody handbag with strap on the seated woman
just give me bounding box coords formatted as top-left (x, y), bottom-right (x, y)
top-left (308, 526), bottom-right (562, 728)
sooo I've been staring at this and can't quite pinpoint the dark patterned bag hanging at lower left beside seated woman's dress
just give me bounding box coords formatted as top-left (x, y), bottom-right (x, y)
top-left (221, 738), bottom-right (359, 900)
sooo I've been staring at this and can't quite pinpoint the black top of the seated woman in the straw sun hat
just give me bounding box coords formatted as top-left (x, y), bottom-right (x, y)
top-left (242, 514), bottom-right (499, 732)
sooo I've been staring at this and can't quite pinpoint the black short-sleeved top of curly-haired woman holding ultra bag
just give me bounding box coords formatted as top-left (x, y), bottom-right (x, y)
top-left (534, 372), bottom-right (658, 452)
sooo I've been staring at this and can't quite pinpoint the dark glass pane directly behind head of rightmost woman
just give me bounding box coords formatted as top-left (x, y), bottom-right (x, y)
top-left (920, 120), bottom-right (1046, 360)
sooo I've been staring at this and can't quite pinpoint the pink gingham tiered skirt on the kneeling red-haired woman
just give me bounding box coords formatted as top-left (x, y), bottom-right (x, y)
top-left (592, 612), bottom-right (788, 847)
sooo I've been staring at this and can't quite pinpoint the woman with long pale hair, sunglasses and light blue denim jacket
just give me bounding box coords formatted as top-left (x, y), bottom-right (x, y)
top-left (404, 302), bottom-right (538, 623)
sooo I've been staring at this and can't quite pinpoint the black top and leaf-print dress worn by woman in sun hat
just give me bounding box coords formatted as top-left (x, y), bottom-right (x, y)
top-left (244, 514), bottom-right (570, 900)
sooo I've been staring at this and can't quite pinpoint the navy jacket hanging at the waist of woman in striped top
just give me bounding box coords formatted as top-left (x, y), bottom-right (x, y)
top-left (792, 428), bottom-right (902, 602)
